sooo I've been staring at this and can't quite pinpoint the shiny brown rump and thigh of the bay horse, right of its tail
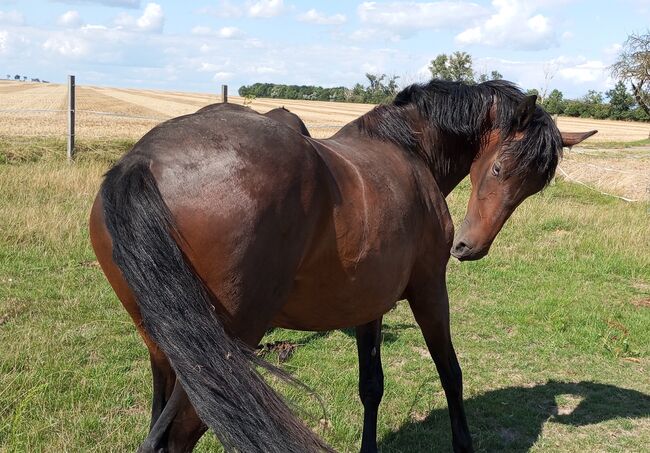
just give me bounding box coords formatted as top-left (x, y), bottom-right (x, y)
top-left (136, 112), bottom-right (325, 344)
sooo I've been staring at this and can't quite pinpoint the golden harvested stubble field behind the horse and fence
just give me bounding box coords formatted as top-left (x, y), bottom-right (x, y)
top-left (0, 81), bottom-right (650, 200)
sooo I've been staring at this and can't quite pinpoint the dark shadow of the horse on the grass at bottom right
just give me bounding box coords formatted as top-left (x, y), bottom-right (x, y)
top-left (380, 381), bottom-right (650, 453)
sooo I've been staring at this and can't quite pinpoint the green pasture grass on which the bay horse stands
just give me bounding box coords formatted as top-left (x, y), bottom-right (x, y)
top-left (0, 142), bottom-right (650, 452)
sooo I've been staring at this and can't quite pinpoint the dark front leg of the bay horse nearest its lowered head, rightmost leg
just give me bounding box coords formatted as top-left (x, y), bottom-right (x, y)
top-left (408, 275), bottom-right (474, 452)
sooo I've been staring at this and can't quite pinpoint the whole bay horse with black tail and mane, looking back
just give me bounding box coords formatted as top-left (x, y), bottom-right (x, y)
top-left (90, 81), bottom-right (595, 453)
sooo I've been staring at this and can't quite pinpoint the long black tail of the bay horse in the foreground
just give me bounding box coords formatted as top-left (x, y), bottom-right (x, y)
top-left (101, 156), bottom-right (333, 453)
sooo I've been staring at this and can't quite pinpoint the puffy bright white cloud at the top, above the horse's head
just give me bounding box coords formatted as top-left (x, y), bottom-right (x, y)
top-left (456, 0), bottom-right (558, 50)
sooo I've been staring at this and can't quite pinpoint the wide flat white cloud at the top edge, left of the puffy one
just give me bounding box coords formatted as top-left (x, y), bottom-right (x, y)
top-left (357, 1), bottom-right (488, 32)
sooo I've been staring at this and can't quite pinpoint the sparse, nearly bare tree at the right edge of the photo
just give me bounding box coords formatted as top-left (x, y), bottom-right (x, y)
top-left (611, 30), bottom-right (650, 115)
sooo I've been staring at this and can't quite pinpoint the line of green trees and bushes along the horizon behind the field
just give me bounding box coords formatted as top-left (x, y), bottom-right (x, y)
top-left (239, 31), bottom-right (650, 121)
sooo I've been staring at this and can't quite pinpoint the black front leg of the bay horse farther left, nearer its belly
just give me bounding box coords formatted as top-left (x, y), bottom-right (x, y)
top-left (356, 318), bottom-right (384, 453)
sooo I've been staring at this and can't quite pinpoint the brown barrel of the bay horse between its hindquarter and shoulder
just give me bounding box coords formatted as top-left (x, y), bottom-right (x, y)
top-left (274, 140), bottom-right (423, 330)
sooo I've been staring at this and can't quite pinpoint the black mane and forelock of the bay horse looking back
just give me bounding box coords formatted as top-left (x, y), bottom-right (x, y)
top-left (357, 80), bottom-right (562, 182)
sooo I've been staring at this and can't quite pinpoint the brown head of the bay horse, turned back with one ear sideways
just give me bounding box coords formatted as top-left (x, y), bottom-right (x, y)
top-left (451, 96), bottom-right (597, 261)
